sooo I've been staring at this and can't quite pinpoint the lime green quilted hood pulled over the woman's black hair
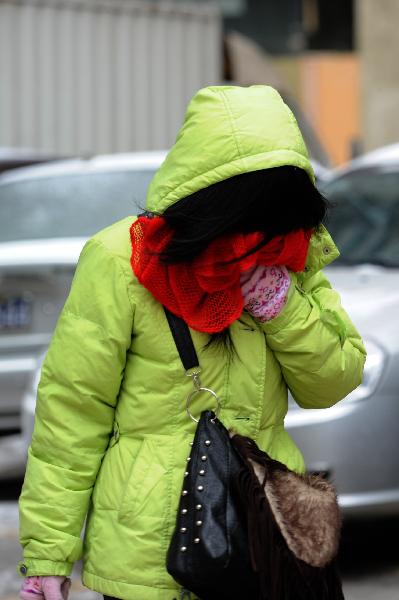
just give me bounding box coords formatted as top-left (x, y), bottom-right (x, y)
top-left (147, 85), bottom-right (314, 213)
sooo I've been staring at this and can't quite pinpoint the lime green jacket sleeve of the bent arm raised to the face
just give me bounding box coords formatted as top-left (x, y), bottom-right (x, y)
top-left (262, 271), bottom-right (366, 408)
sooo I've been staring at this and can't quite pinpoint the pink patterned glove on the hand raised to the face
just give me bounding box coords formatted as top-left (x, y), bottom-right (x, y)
top-left (241, 265), bottom-right (291, 323)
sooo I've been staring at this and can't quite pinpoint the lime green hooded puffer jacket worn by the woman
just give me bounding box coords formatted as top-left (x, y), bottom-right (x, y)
top-left (19, 86), bottom-right (365, 600)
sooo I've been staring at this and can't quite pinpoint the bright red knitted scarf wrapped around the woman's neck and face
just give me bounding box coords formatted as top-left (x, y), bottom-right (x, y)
top-left (130, 217), bottom-right (312, 333)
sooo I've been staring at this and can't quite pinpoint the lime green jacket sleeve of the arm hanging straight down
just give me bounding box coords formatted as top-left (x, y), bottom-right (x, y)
top-left (19, 238), bottom-right (133, 576)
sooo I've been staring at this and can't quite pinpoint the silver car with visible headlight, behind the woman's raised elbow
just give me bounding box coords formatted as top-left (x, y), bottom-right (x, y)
top-left (286, 144), bottom-right (399, 516)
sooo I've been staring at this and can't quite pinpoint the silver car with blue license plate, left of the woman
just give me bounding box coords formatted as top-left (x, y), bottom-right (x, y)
top-left (0, 152), bottom-right (165, 433)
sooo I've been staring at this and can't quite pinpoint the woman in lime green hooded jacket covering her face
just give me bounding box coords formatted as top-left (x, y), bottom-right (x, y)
top-left (19, 86), bottom-right (365, 600)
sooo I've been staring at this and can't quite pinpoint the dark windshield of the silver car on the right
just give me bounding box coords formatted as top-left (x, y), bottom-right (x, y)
top-left (321, 169), bottom-right (399, 267)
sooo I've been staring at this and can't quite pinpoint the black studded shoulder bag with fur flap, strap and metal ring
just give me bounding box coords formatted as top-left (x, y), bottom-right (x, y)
top-left (165, 308), bottom-right (344, 600)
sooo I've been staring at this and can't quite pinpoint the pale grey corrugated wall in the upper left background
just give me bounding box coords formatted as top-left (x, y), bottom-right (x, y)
top-left (0, 0), bottom-right (221, 155)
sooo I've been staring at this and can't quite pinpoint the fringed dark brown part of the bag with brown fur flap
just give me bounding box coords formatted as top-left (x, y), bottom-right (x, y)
top-left (230, 434), bottom-right (344, 600)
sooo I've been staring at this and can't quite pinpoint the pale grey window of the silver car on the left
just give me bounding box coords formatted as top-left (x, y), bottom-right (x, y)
top-left (0, 169), bottom-right (154, 242)
